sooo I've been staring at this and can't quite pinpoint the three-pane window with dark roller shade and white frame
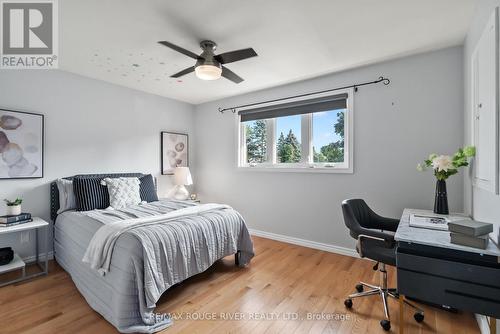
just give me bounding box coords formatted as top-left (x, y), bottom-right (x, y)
top-left (238, 89), bottom-right (353, 173)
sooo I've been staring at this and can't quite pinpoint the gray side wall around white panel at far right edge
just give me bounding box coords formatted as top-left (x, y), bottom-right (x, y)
top-left (464, 0), bottom-right (500, 225)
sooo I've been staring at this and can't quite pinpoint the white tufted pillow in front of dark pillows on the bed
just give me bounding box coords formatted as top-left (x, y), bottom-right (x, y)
top-left (101, 177), bottom-right (141, 209)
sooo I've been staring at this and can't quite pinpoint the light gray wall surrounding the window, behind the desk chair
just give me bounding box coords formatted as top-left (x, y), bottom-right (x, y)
top-left (195, 47), bottom-right (463, 248)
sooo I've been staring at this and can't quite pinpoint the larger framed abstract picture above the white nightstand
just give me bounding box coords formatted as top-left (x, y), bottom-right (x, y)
top-left (0, 108), bottom-right (44, 180)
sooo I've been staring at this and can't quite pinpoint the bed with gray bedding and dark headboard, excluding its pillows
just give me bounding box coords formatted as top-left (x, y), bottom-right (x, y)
top-left (51, 173), bottom-right (254, 333)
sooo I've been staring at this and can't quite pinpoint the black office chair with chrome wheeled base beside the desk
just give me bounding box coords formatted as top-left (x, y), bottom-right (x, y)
top-left (342, 199), bottom-right (424, 331)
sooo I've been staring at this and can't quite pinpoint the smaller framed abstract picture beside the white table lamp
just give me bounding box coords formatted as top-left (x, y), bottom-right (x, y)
top-left (161, 131), bottom-right (189, 175)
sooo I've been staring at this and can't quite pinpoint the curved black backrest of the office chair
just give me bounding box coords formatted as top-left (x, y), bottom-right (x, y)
top-left (342, 199), bottom-right (374, 239)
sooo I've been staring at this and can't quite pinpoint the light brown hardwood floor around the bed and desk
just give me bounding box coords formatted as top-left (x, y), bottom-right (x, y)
top-left (0, 237), bottom-right (479, 334)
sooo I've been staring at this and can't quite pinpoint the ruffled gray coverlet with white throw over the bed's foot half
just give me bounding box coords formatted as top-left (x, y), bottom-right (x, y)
top-left (82, 201), bottom-right (254, 314)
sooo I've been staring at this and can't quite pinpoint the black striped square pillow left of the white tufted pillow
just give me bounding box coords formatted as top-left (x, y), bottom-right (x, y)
top-left (73, 177), bottom-right (109, 211)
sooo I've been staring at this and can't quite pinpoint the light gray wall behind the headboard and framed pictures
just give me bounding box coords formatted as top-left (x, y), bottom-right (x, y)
top-left (0, 70), bottom-right (194, 257)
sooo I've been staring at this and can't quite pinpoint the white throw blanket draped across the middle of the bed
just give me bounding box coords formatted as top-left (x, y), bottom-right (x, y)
top-left (82, 203), bottom-right (231, 275)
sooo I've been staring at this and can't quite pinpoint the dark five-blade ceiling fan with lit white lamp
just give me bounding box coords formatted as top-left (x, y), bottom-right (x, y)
top-left (158, 41), bottom-right (257, 83)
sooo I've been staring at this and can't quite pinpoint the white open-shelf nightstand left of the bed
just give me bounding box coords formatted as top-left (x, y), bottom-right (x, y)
top-left (0, 217), bottom-right (50, 287)
